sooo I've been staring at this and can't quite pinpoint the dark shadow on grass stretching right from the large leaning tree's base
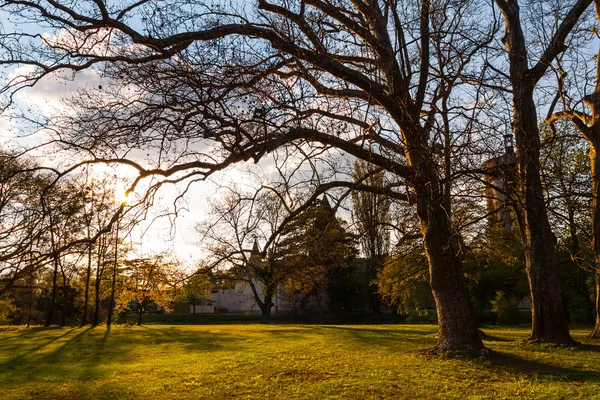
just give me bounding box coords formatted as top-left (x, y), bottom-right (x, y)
top-left (489, 352), bottom-right (600, 383)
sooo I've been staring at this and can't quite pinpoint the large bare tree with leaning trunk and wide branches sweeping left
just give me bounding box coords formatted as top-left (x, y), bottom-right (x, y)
top-left (1, 0), bottom-right (497, 351)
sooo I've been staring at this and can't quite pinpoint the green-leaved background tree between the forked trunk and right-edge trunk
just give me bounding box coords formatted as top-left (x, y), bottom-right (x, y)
top-left (540, 121), bottom-right (594, 323)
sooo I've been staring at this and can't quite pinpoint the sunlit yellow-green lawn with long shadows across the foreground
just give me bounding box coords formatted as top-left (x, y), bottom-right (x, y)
top-left (0, 324), bottom-right (600, 399)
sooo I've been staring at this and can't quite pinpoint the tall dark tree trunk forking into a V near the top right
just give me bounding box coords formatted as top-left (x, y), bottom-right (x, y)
top-left (494, 0), bottom-right (592, 344)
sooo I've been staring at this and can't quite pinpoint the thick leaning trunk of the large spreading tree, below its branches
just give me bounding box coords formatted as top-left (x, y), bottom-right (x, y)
top-left (417, 184), bottom-right (486, 352)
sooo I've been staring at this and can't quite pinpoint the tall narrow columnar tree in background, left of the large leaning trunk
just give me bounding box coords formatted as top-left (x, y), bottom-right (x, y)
top-left (352, 160), bottom-right (390, 313)
